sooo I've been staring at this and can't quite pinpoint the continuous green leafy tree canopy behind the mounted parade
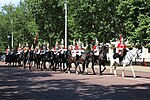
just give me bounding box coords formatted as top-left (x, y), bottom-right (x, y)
top-left (0, 0), bottom-right (150, 50)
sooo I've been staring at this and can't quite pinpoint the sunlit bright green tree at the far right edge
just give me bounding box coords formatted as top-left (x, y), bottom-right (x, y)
top-left (117, 0), bottom-right (150, 45)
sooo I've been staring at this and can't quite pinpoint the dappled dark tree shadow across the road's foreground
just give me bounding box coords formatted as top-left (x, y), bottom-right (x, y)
top-left (0, 68), bottom-right (150, 100)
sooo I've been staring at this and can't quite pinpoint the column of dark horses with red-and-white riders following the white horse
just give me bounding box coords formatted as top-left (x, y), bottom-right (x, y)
top-left (5, 39), bottom-right (107, 74)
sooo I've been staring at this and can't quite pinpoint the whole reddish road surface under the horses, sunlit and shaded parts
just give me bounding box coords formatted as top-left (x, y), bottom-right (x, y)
top-left (0, 62), bottom-right (150, 100)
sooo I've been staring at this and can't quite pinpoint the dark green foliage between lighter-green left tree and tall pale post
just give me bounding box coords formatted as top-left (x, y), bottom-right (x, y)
top-left (29, 0), bottom-right (64, 44)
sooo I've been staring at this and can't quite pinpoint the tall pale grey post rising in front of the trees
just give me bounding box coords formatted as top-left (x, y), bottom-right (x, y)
top-left (64, 1), bottom-right (68, 50)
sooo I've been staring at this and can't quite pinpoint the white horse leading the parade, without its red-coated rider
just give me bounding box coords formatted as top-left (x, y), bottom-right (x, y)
top-left (110, 48), bottom-right (140, 78)
